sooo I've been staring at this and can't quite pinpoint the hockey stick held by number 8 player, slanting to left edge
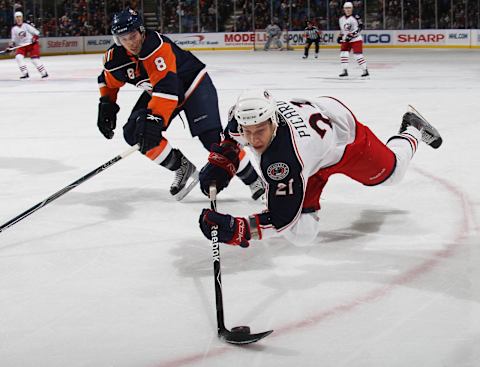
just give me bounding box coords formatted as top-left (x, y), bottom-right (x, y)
top-left (0, 144), bottom-right (140, 233)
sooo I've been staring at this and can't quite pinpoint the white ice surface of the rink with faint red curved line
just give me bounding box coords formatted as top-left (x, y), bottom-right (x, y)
top-left (0, 50), bottom-right (480, 367)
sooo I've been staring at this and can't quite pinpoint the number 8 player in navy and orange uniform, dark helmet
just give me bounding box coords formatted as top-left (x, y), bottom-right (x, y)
top-left (97, 9), bottom-right (264, 200)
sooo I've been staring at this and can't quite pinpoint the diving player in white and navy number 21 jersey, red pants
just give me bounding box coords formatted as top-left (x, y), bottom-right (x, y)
top-left (199, 90), bottom-right (442, 247)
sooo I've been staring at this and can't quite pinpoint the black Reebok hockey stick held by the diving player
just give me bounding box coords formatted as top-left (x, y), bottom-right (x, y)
top-left (210, 183), bottom-right (273, 344)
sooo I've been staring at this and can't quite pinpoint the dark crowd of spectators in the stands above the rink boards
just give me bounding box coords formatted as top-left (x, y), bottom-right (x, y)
top-left (0, 0), bottom-right (480, 38)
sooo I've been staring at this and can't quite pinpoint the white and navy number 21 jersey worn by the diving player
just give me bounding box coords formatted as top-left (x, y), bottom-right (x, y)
top-left (225, 97), bottom-right (356, 243)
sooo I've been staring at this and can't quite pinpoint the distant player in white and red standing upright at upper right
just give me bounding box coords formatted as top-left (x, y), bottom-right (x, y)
top-left (337, 1), bottom-right (369, 77)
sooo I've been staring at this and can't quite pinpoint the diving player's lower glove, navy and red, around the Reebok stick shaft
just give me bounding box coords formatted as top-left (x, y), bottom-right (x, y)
top-left (198, 209), bottom-right (251, 247)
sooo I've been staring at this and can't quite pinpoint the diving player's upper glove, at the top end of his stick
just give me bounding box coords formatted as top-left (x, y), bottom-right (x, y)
top-left (199, 140), bottom-right (240, 196)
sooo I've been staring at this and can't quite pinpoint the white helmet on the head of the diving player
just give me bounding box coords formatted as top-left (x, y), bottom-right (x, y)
top-left (234, 89), bottom-right (277, 126)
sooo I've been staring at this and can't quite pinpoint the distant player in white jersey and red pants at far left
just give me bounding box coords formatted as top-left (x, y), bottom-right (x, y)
top-left (9, 11), bottom-right (48, 79)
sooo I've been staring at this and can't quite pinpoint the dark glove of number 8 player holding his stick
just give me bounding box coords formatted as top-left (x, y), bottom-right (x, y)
top-left (123, 108), bottom-right (164, 154)
